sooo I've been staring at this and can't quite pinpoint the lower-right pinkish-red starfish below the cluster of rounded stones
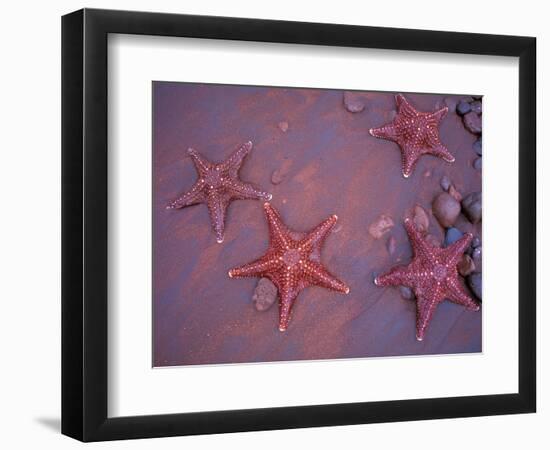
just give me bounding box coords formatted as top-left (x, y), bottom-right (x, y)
top-left (374, 219), bottom-right (479, 341)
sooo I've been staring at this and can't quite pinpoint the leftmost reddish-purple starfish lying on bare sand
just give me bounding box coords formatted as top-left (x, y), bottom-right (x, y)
top-left (166, 141), bottom-right (271, 243)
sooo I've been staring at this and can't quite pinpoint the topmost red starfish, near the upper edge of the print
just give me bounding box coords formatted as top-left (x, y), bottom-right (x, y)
top-left (369, 94), bottom-right (455, 178)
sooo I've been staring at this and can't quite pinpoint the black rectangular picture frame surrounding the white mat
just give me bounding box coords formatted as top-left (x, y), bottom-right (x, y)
top-left (62, 9), bottom-right (536, 441)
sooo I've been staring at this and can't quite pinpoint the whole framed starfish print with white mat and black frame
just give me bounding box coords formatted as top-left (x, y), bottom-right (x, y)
top-left (62, 9), bottom-right (536, 441)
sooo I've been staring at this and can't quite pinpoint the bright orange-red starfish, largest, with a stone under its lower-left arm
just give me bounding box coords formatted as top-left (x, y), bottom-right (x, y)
top-left (229, 203), bottom-right (349, 331)
